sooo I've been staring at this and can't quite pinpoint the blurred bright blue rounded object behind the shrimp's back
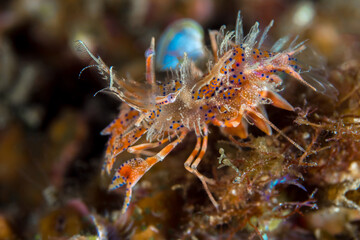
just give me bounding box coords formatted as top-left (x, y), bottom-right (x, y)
top-left (156, 19), bottom-right (205, 70)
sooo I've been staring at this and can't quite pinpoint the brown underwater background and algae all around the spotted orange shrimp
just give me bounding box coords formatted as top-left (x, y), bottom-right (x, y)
top-left (0, 0), bottom-right (360, 240)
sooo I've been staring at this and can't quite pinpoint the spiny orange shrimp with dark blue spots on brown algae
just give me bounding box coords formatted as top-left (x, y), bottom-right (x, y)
top-left (80, 13), bottom-right (336, 212)
